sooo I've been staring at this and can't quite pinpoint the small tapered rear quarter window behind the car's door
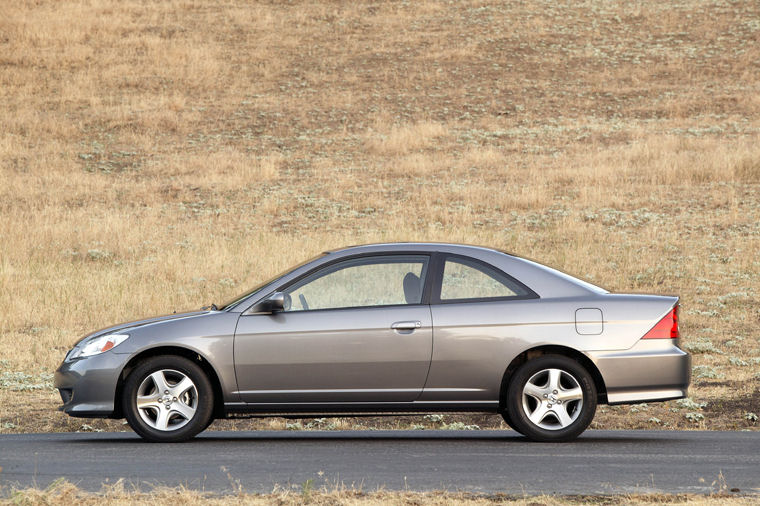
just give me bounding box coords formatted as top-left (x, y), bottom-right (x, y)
top-left (441, 258), bottom-right (530, 301)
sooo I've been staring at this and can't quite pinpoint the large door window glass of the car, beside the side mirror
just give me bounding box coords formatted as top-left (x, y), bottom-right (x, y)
top-left (285, 255), bottom-right (428, 311)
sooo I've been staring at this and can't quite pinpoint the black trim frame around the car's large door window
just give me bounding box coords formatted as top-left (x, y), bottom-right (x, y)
top-left (260, 251), bottom-right (435, 314)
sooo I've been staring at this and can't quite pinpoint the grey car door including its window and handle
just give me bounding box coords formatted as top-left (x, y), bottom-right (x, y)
top-left (235, 255), bottom-right (433, 404)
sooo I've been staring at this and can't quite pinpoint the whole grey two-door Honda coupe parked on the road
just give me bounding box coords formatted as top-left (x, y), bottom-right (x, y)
top-left (55, 243), bottom-right (691, 442)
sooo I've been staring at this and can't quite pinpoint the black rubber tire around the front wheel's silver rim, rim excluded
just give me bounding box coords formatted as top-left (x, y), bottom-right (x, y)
top-left (122, 355), bottom-right (214, 443)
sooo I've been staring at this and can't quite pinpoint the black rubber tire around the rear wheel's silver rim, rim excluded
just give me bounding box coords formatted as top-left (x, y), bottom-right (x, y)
top-left (506, 355), bottom-right (597, 442)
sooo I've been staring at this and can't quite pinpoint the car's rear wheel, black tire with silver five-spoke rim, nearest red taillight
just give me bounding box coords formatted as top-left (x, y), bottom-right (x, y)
top-left (506, 355), bottom-right (596, 442)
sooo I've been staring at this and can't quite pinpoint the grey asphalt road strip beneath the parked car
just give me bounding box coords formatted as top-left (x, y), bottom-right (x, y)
top-left (0, 431), bottom-right (760, 494)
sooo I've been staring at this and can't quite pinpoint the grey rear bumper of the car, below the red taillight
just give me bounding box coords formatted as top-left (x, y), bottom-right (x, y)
top-left (586, 339), bottom-right (691, 404)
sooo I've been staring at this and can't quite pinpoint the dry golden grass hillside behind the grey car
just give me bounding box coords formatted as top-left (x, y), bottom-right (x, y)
top-left (0, 0), bottom-right (760, 432)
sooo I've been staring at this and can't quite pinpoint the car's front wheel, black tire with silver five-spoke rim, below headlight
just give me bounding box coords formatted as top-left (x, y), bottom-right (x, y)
top-left (122, 355), bottom-right (214, 443)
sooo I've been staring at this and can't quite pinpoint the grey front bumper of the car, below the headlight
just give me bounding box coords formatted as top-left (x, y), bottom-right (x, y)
top-left (53, 351), bottom-right (129, 418)
